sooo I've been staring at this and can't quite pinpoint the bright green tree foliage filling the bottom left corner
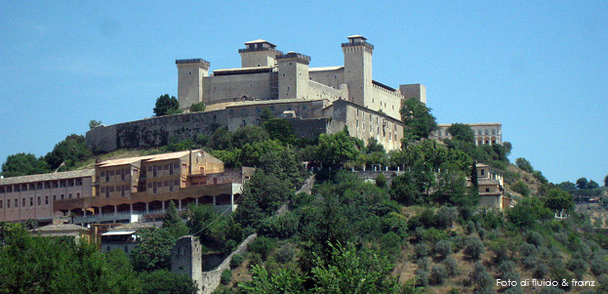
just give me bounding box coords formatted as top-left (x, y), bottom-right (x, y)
top-left (0, 224), bottom-right (141, 294)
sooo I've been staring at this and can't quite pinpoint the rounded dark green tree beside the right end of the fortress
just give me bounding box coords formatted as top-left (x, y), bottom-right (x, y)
top-left (400, 99), bottom-right (437, 142)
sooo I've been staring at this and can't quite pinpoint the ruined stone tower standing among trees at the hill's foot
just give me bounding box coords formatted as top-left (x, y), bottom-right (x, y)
top-left (171, 235), bottom-right (203, 293)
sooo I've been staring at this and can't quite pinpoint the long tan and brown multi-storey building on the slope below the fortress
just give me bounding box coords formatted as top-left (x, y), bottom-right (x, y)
top-left (0, 150), bottom-right (254, 224)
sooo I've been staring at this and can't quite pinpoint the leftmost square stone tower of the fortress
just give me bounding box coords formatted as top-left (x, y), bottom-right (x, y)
top-left (175, 58), bottom-right (209, 109)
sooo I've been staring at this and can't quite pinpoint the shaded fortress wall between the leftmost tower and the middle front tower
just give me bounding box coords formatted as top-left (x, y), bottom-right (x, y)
top-left (203, 72), bottom-right (278, 105)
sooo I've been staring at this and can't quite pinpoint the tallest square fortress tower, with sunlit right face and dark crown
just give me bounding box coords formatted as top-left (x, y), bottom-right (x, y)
top-left (342, 35), bottom-right (374, 106)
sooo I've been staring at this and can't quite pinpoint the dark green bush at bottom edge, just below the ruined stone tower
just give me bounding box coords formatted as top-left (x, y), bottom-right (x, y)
top-left (140, 270), bottom-right (198, 294)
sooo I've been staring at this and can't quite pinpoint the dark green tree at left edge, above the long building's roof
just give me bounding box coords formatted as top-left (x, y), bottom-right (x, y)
top-left (2, 153), bottom-right (50, 178)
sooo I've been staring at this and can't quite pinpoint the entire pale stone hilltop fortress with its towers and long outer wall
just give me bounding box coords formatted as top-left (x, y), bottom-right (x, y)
top-left (87, 35), bottom-right (426, 151)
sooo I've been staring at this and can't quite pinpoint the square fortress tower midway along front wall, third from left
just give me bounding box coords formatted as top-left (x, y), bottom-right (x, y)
top-left (277, 52), bottom-right (310, 99)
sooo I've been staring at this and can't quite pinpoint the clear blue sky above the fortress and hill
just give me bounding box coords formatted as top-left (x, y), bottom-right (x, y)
top-left (0, 1), bottom-right (608, 184)
